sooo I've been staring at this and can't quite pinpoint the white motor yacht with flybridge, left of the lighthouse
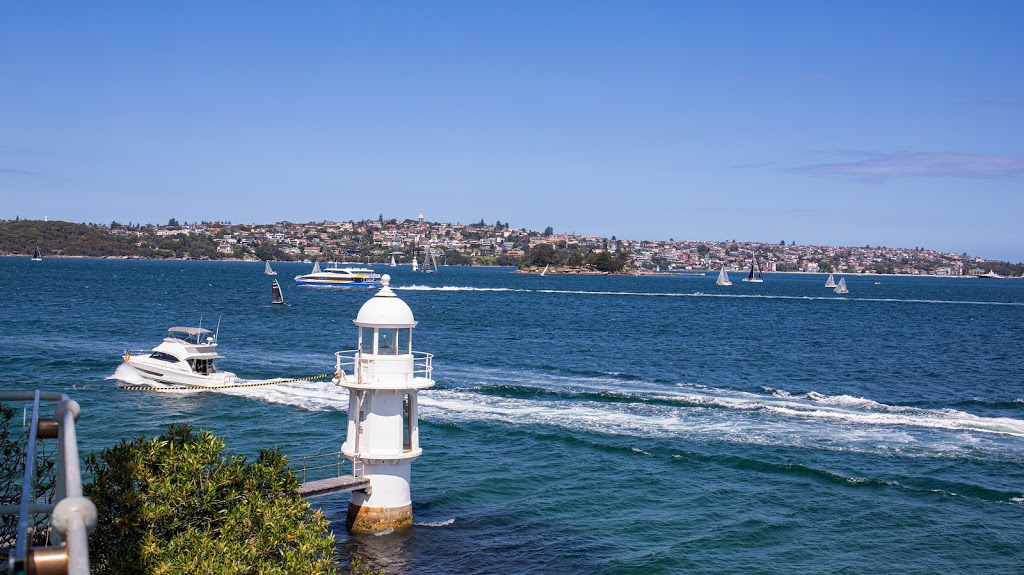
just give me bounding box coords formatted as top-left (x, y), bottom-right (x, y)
top-left (124, 327), bottom-right (234, 388)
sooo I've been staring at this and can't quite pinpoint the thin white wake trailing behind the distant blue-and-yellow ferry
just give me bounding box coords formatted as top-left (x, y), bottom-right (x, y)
top-left (392, 285), bottom-right (1024, 307)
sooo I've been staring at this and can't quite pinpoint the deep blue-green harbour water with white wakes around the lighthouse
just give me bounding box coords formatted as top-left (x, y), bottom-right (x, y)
top-left (0, 258), bottom-right (1024, 575)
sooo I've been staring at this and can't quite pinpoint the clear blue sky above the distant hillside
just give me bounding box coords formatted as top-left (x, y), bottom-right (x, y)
top-left (0, 0), bottom-right (1024, 262)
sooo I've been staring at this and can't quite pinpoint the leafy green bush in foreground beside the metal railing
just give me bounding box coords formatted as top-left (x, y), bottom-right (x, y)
top-left (85, 425), bottom-right (338, 574)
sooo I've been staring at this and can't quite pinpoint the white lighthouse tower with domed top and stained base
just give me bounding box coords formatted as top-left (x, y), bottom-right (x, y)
top-left (335, 275), bottom-right (434, 533)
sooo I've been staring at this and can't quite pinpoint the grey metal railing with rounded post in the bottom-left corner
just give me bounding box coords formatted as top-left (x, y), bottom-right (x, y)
top-left (0, 391), bottom-right (96, 575)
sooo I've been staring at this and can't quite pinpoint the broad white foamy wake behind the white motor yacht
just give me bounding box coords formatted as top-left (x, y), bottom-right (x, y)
top-left (110, 367), bottom-right (1024, 459)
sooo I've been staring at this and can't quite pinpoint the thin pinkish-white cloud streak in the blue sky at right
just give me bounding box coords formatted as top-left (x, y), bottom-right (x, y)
top-left (794, 152), bottom-right (1024, 183)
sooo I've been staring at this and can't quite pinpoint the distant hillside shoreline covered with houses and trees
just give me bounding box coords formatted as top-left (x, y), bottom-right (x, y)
top-left (0, 217), bottom-right (1024, 276)
